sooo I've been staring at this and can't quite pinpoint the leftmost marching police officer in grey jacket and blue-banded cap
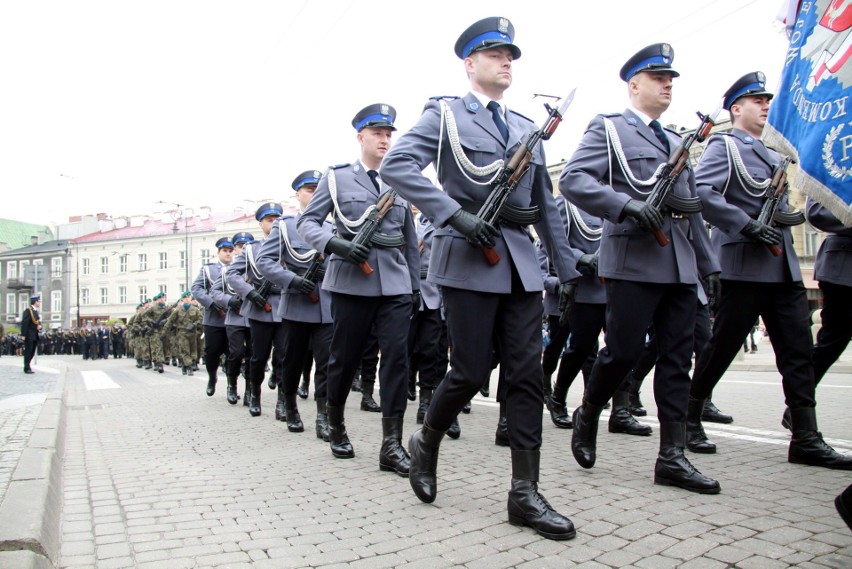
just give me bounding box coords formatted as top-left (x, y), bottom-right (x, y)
top-left (190, 237), bottom-right (234, 397)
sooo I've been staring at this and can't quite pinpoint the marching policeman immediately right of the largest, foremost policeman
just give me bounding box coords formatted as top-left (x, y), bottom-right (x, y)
top-left (559, 43), bottom-right (720, 494)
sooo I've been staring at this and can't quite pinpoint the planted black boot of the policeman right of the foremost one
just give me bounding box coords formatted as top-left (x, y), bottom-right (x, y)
top-left (654, 421), bottom-right (722, 494)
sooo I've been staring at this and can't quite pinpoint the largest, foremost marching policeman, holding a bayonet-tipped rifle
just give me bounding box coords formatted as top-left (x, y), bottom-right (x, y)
top-left (382, 17), bottom-right (579, 539)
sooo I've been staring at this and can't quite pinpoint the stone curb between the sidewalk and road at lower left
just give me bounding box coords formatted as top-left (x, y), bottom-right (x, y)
top-left (0, 365), bottom-right (68, 569)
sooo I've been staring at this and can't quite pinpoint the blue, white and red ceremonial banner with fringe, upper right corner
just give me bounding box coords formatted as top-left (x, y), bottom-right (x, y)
top-left (763, 0), bottom-right (852, 225)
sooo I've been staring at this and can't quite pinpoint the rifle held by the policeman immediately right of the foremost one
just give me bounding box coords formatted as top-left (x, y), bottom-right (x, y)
top-left (645, 101), bottom-right (722, 247)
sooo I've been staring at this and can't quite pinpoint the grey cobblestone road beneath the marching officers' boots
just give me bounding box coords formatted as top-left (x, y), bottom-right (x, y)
top-left (45, 348), bottom-right (852, 569)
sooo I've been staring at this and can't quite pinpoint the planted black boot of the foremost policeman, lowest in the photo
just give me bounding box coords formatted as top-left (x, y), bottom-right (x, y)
top-left (508, 450), bottom-right (577, 540)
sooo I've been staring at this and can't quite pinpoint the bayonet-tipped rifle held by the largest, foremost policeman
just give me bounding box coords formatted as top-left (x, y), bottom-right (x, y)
top-left (476, 89), bottom-right (577, 265)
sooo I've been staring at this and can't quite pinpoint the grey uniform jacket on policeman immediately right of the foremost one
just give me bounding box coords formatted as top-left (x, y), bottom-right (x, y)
top-left (559, 109), bottom-right (719, 284)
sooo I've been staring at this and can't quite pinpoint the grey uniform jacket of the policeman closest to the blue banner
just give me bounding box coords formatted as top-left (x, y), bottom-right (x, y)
top-left (695, 128), bottom-right (802, 283)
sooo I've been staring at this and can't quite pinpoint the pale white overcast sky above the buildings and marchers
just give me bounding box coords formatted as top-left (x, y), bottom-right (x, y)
top-left (0, 0), bottom-right (787, 223)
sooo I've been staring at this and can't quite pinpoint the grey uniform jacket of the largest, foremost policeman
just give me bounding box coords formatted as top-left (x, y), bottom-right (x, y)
top-left (381, 93), bottom-right (579, 294)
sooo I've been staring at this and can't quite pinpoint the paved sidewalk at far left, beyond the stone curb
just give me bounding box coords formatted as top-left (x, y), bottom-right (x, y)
top-left (0, 356), bottom-right (59, 503)
